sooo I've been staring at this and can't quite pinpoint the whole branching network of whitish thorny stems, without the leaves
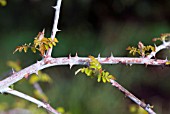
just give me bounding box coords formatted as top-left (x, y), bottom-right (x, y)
top-left (0, 0), bottom-right (170, 114)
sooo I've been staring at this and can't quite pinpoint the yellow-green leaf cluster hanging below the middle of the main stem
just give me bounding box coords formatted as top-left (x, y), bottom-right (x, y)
top-left (75, 56), bottom-right (115, 83)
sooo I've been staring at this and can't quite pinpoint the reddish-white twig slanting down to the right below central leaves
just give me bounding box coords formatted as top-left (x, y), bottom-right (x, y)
top-left (110, 80), bottom-right (156, 114)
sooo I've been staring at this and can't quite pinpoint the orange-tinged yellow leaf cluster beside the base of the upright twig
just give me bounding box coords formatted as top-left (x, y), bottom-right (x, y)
top-left (13, 30), bottom-right (58, 56)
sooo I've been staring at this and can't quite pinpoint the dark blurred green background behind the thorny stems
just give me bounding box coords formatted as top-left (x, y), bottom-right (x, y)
top-left (0, 0), bottom-right (170, 114)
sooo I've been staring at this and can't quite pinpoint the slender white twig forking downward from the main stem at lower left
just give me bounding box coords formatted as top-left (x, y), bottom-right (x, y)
top-left (5, 88), bottom-right (60, 114)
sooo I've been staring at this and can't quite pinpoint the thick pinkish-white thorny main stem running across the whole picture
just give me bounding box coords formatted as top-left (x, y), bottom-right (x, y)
top-left (0, 56), bottom-right (167, 92)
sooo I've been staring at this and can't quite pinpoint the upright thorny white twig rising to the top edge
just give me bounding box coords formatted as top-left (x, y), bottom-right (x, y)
top-left (46, 0), bottom-right (62, 57)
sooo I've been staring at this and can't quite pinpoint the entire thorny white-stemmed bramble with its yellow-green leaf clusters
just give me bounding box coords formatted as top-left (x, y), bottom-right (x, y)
top-left (0, 0), bottom-right (170, 114)
